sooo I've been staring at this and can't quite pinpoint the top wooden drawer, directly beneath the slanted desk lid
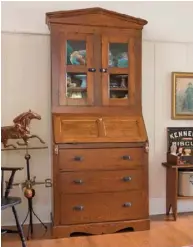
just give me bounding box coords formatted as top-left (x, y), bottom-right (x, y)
top-left (58, 148), bottom-right (144, 171)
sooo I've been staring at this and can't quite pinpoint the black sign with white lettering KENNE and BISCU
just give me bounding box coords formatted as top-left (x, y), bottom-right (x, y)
top-left (167, 127), bottom-right (193, 156)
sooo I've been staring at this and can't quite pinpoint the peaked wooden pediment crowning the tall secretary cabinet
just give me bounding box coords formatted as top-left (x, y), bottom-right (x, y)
top-left (46, 8), bottom-right (147, 29)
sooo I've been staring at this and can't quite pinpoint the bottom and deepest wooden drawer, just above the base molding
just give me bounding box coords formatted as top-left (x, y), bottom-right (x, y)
top-left (60, 191), bottom-right (148, 225)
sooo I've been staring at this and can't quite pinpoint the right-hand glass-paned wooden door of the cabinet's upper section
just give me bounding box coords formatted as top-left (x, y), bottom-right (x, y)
top-left (101, 36), bottom-right (135, 105)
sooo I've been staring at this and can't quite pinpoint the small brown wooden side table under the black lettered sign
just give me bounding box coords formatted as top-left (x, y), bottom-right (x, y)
top-left (162, 162), bottom-right (193, 221)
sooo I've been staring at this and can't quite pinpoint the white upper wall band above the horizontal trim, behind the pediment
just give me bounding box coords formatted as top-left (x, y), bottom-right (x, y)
top-left (2, 1), bottom-right (193, 42)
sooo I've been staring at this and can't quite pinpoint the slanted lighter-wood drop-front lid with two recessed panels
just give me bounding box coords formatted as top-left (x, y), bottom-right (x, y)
top-left (53, 114), bottom-right (147, 143)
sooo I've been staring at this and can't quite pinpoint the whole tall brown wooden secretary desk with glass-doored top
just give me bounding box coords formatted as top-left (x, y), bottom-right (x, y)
top-left (46, 8), bottom-right (150, 237)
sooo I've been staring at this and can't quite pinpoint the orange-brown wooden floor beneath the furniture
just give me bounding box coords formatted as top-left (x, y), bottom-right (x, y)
top-left (2, 214), bottom-right (193, 247)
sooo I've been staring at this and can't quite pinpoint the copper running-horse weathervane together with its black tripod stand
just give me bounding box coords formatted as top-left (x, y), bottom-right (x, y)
top-left (1, 110), bottom-right (49, 239)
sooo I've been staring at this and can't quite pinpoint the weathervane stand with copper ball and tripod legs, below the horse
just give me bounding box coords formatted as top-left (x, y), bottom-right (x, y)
top-left (2, 146), bottom-right (52, 239)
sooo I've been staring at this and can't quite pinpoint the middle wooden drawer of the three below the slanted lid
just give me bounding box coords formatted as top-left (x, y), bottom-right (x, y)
top-left (57, 169), bottom-right (144, 194)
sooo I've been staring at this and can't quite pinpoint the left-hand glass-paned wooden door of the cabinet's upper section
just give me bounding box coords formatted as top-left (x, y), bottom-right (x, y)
top-left (59, 34), bottom-right (95, 106)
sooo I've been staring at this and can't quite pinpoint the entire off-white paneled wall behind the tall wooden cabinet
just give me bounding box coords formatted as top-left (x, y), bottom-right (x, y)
top-left (1, 2), bottom-right (193, 225)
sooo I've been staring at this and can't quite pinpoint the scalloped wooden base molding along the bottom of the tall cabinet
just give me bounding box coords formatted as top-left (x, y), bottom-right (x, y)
top-left (52, 219), bottom-right (150, 238)
